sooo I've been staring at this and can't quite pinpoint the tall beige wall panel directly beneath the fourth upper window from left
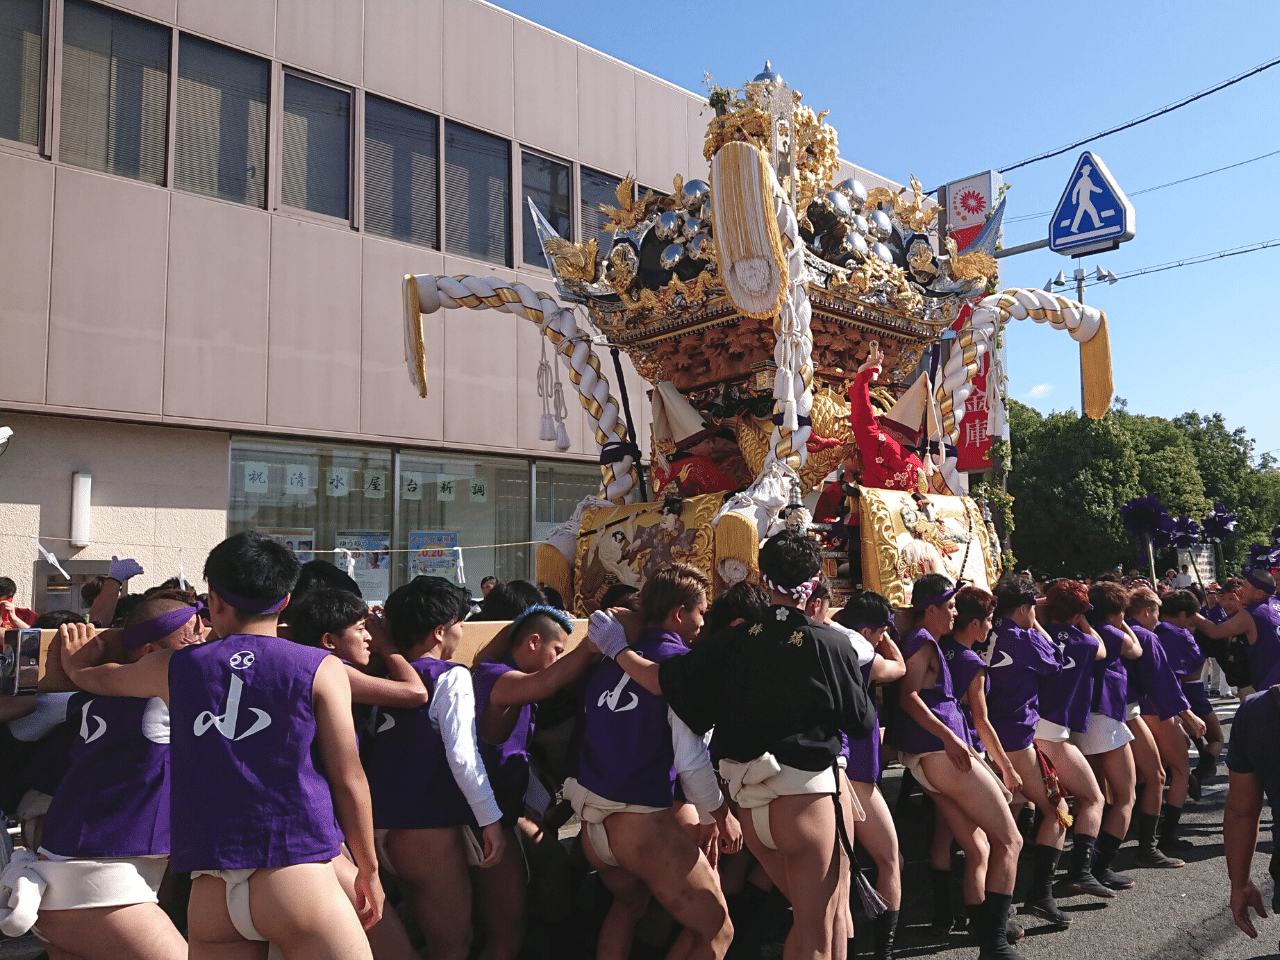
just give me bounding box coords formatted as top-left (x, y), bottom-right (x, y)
top-left (266, 216), bottom-right (361, 433)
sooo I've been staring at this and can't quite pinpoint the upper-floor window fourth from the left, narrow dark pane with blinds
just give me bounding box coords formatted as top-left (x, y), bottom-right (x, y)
top-left (280, 73), bottom-right (351, 220)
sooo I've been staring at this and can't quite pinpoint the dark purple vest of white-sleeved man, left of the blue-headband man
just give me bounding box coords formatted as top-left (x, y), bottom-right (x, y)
top-left (365, 657), bottom-right (475, 829)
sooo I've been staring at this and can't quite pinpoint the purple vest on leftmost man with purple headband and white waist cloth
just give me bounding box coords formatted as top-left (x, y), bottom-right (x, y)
top-left (42, 694), bottom-right (169, 858)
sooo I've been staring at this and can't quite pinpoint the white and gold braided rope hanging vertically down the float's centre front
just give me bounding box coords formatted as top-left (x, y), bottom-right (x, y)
top-left (758, 196), bottom-right (813, 479)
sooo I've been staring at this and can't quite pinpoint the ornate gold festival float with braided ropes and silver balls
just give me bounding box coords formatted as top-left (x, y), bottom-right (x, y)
top-left (403, 64), bottom-right (1111, 616)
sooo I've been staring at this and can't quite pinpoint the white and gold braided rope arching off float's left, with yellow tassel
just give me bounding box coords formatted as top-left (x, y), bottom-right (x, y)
top-left (404, 274), bottom-right (639, 503)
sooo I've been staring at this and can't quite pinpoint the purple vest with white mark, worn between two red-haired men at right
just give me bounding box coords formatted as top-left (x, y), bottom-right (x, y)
top-left (987, 617), bottom-right (1062, 751)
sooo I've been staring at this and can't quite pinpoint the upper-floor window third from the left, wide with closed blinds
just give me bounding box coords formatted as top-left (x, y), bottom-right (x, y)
top-left (174, 35), bottom-right (270, 207)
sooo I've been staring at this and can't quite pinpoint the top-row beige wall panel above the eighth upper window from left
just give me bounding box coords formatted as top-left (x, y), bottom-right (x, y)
top-left (577, 47), bottom-right (637, 180)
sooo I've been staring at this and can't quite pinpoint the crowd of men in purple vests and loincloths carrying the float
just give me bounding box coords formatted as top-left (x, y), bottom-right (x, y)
top-left (0, 542), bottom-right (1280, 960)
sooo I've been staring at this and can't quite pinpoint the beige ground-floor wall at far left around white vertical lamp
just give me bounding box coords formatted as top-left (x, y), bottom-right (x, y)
top-left (0, 413), bottom-right (229, 602)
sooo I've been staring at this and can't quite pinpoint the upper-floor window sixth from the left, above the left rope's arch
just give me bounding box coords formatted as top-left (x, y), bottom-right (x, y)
top-left (444, 123), bottom-right (511, 266)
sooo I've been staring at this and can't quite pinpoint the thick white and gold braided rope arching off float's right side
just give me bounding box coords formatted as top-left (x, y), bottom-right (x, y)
top-left (934, 288), bottom-right (1102, 443)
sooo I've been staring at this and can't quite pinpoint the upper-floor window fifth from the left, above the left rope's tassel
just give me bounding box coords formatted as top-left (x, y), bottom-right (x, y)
top-left (365, 95), bottom-right (440, 248)
